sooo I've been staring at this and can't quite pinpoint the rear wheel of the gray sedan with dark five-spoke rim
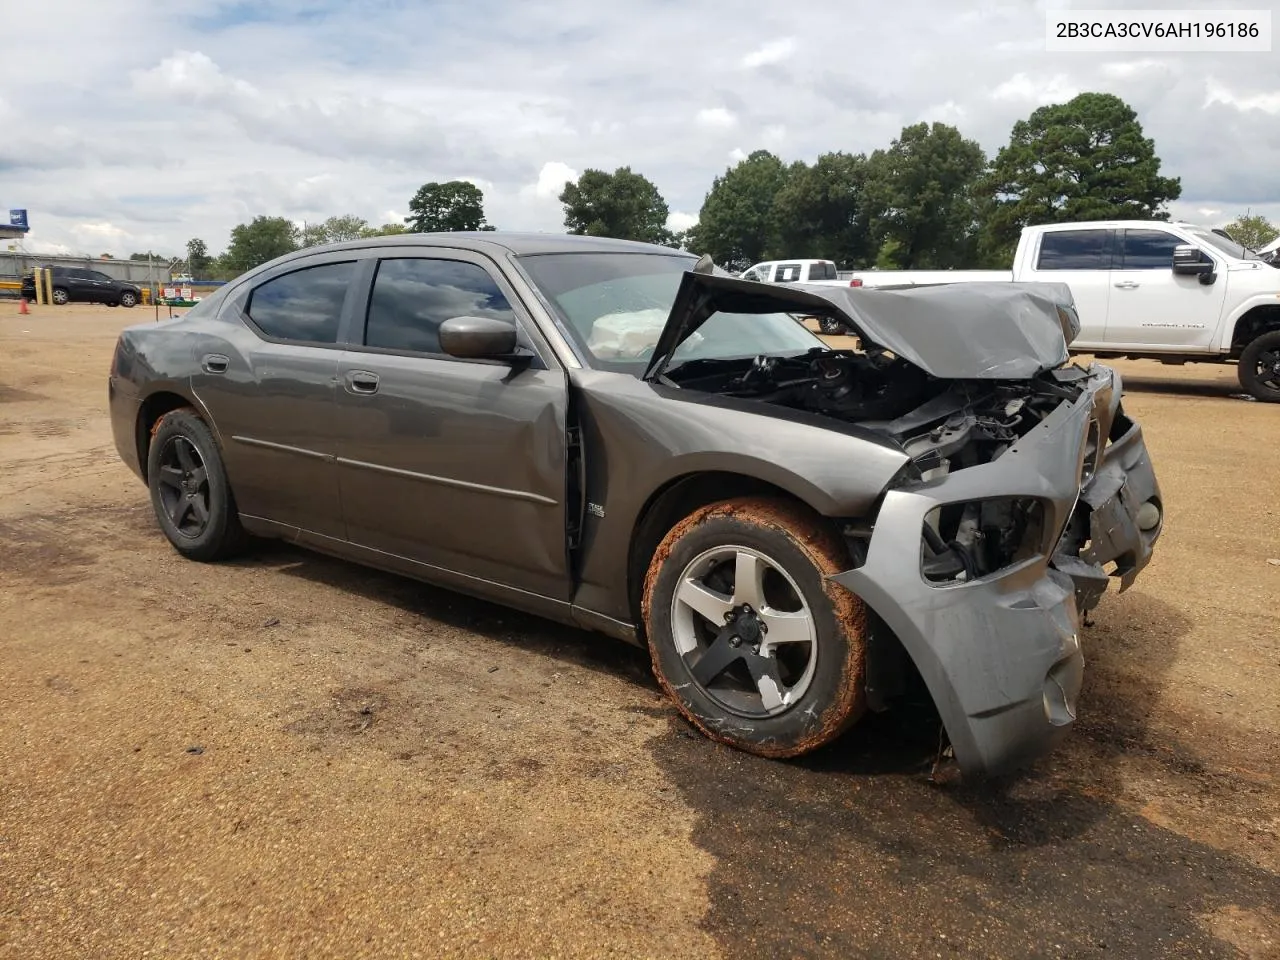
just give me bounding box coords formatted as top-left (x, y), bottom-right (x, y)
top-left (147, 407), bottom-right (248, 562)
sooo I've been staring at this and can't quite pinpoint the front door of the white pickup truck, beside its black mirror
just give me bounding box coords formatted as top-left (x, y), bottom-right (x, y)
top-left (1107, 228), bottom-right (1226, 351)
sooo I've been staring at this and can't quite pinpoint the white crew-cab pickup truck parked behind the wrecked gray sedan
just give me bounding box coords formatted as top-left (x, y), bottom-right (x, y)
top-left (851, 220), bottom-right (1280, 403)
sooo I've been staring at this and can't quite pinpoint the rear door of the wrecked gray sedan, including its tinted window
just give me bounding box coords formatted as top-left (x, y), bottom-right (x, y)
top-left (192, 252), bottom-right (360, 539)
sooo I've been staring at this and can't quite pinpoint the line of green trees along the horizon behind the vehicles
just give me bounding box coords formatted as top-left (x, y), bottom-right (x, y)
top-left (172, 93), bottom-right (1277, 278)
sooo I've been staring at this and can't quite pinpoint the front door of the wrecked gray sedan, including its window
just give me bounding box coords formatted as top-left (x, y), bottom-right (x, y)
top-left (337, 247), bottom-right (571, 600)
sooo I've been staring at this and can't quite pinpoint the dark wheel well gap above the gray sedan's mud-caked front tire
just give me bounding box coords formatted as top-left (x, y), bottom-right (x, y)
top-left (627, 472), bottom-right (834, 637)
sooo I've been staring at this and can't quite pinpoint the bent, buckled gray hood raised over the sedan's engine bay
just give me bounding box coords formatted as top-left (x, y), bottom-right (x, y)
top-left (644, 273), bottom-right (1080, 380)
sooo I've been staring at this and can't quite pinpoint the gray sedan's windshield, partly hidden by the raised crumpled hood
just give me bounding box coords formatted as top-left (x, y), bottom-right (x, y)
top-left (520, 253), bottom-right (826, 376)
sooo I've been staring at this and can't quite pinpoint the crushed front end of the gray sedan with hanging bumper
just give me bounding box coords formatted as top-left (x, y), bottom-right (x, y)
top-left (835, 365), bottom-right (1164, 774)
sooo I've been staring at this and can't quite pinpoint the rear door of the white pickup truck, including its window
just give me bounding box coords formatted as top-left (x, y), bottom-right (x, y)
top-left (1019, 227), bottom-right (1115, 349)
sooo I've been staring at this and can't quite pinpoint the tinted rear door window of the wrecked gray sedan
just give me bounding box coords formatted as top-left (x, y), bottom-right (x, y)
top-left (247, 262), bottom-right (356, 343)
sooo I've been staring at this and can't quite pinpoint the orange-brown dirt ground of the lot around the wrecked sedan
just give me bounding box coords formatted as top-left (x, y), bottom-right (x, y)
top-left (0, 301), bottom-right (1280, 960)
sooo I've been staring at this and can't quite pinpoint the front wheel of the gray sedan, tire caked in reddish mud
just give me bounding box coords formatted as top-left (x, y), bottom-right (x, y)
top-left (641, 497), bottom-right (867, 758)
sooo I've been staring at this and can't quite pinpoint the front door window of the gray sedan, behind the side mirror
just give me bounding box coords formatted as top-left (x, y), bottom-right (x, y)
top-left (365, 257), bottom-right (516, 353)
